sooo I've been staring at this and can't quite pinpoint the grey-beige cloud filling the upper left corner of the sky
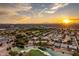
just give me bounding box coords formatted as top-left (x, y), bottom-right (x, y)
top-left (0, 3), bottom-right (32, 16)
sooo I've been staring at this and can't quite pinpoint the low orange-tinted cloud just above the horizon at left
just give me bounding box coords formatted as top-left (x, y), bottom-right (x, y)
top-left (0, 16), bottom-right (31, 24)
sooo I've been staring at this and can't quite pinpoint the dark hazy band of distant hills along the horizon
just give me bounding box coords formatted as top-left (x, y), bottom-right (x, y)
top-left (0, 23), bottom-right (79, 29)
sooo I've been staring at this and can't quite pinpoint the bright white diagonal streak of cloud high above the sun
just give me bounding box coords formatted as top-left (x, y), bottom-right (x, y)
top-left (45, 3), bottom-right (69, 14)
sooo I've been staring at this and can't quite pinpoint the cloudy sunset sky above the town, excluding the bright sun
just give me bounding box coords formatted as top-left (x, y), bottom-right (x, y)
top-left (0, 3), bottom-right (79, 24)
